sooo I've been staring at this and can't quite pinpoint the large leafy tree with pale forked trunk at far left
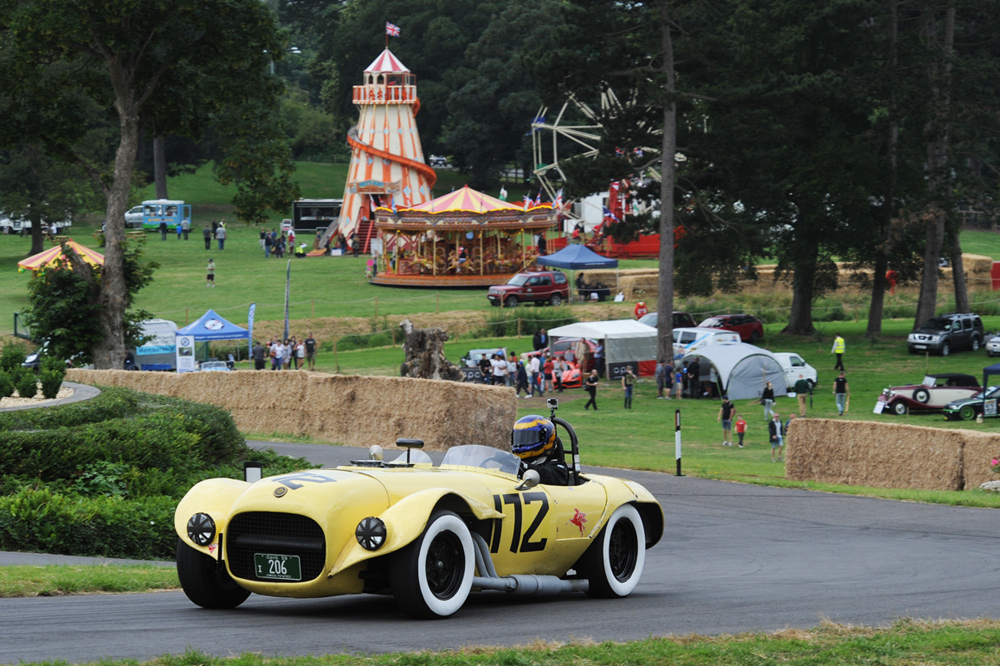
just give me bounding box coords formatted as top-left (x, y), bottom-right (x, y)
top-left (0, 0), bottom-right (282, 368)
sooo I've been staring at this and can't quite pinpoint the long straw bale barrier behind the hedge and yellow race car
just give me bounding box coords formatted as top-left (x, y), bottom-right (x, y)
top-left (66, 368), bottom-right (517, 451)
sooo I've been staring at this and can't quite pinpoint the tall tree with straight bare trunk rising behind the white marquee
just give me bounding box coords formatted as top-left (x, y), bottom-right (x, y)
top-left (533, 0), bottom-right (678, 358)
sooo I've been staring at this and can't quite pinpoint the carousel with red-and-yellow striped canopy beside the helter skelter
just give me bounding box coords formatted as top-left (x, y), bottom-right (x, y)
top-left (371, 186), bottom-right (557, 287)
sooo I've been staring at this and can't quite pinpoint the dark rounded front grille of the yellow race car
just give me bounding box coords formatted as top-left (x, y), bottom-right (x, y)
top-left (224, 511), bottom-right (326, 582)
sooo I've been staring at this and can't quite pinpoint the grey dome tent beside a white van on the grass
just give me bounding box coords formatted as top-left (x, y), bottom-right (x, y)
top-left (684, 342), bottom-right (788, 400)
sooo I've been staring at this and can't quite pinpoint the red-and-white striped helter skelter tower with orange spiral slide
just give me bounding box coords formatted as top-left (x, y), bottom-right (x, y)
top-left (323, 48), bottom-right (437, 252)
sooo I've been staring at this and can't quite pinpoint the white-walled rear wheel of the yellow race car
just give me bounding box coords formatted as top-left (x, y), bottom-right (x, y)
top-left (577, 504), bottom-right (646, 599)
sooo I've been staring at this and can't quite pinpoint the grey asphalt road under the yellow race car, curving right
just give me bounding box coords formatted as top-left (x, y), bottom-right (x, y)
top-left (0, 438), bottom-right (1000, 664)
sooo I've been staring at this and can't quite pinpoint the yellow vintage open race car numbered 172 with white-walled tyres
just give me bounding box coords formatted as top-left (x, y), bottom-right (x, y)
top-left (174, 401), bottom-right (663, 618)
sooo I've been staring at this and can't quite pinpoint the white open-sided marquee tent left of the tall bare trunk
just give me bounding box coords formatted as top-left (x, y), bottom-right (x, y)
top-left (549, 319), bottom-right (656, 378)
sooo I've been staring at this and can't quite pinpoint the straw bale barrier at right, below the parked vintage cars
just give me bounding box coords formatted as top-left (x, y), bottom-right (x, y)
top-left (785, 419), bottom-right (1000, 490)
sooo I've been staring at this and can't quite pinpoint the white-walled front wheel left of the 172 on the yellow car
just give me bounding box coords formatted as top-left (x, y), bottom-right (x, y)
top-left (389, 511), bottom-right (476, 619)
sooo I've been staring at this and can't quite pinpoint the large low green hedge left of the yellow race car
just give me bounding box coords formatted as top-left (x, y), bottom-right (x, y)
top-left (0, 384), bottom-right (315, 559)
